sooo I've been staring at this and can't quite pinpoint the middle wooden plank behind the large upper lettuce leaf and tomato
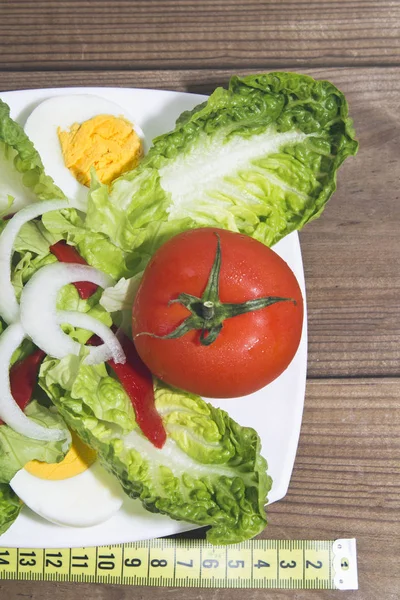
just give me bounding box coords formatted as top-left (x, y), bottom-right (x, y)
top-left (0, 65), bottom-right (400, 377)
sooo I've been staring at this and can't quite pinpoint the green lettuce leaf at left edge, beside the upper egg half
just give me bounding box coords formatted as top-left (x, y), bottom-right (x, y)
top-left (0, 100), bottom-right (64, 214)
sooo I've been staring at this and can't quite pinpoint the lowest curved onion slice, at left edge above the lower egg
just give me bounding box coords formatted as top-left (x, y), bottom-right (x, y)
top-left (0, 323), bottom-right (67, 442)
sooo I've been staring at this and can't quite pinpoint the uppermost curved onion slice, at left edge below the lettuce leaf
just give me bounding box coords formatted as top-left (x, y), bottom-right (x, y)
top-left (0, 200), bottom-right (70, 323)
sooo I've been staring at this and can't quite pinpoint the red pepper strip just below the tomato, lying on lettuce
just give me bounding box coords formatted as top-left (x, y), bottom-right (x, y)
top-left (88, 334), bottom-right (167, 448)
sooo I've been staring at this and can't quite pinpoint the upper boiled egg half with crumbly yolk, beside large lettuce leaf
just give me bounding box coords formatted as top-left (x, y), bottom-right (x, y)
top-left (25, 94), bottom-right (143, 210)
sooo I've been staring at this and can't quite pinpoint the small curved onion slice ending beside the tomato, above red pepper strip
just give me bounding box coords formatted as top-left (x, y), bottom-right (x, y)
top-left (57, 310), bottom-right (126, 365)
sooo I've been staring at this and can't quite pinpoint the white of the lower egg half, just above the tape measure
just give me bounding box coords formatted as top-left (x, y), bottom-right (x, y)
top-left (10, 461), bottom-right (126, 527)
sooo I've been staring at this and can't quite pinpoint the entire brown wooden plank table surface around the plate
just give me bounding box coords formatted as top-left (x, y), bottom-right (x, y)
top-left (0, 0), bottom-right (400, 600)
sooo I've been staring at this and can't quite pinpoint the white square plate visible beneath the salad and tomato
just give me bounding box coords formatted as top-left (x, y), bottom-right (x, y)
top-left (0, 88), bottom-right (307, 548)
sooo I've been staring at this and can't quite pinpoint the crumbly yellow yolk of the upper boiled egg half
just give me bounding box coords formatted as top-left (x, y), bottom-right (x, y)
top-left (57, 115), bottom-right (143, 186)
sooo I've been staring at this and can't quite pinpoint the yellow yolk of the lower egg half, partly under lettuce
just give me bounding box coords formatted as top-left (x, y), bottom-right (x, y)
top-left (25, 433), bottom-right (97, 481)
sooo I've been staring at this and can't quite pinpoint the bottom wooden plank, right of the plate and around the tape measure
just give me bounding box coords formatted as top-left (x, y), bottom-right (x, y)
top-left (0, 379), bottom-right (400, 600)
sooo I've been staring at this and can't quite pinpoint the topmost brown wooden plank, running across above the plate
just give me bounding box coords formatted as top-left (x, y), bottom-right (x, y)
top-left (0, 0), bottom-right (400, 70)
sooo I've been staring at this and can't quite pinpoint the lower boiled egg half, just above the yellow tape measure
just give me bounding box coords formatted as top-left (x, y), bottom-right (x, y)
top-left (10, 433), bottom-right (126, 527)
